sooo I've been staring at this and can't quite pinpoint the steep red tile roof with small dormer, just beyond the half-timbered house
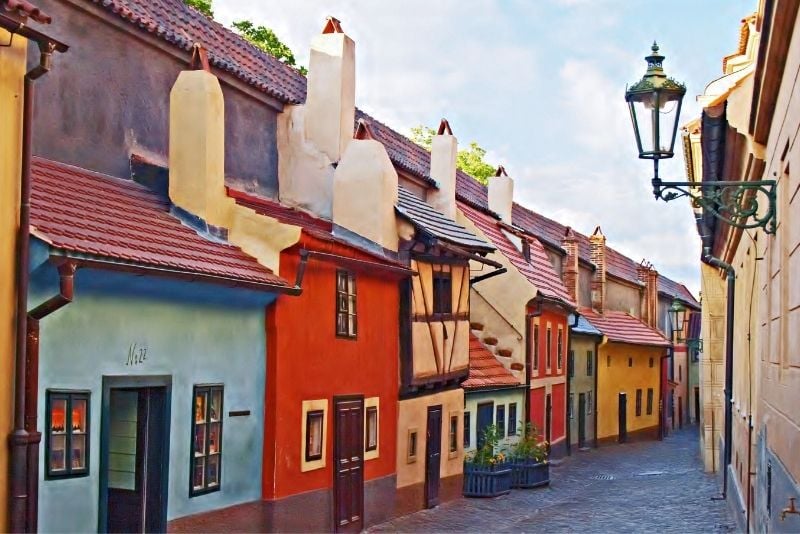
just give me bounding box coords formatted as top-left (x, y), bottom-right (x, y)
top-left (459, 202), bottom-right (576, 306)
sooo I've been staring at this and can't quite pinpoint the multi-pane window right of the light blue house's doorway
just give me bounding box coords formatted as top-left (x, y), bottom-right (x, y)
top-left (189, 386), bottom-right (223, 497)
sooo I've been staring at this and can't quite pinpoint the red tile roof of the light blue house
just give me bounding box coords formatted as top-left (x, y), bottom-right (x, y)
top-left (31, 158), bottom-right (288, 286)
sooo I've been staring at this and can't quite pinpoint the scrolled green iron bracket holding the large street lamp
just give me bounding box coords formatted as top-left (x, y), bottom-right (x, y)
top-left (652, 177), bottom-right (777, 234)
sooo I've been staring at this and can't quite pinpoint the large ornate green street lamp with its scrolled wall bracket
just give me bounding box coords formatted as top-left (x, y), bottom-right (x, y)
top-left (625, 43), bottom-right (776, 234)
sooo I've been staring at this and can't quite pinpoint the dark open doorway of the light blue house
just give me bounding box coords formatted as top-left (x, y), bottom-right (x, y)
top-left (102, 387), bottom-right (167, 532)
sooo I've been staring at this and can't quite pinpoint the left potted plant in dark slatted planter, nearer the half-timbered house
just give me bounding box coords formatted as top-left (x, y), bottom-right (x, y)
top-left (464, 425), bottom-right (511, 497)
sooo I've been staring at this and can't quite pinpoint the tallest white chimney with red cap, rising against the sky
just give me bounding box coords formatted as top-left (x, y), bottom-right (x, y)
top-left (305, 17), bottom-right (356, 162)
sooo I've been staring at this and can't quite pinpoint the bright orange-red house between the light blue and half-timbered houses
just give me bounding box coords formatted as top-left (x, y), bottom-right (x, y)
top-left (229, 191), bottom-right (411, 531)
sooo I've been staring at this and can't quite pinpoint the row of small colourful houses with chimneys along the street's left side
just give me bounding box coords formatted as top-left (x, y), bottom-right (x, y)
top-left (0, 0), bottom-right (699, 531)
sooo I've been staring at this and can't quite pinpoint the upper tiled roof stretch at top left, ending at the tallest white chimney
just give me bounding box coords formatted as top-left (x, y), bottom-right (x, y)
top-left (89, 0), bottom-right (306, 104)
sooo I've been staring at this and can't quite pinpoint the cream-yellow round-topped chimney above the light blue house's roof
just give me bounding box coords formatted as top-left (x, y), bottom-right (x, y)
top-left (169, 45), bottom-right (228, 226)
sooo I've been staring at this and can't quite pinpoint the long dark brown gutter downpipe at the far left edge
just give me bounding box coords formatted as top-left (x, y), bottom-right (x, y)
top-left (5, 19), bottom-right (69, 532)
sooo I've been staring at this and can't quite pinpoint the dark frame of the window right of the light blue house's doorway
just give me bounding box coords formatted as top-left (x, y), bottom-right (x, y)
top-left (189, 384), bottom-right (225, 498)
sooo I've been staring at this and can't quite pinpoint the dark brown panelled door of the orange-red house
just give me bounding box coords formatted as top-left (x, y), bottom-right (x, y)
top-left (333, 397), bottom-right (364, 532)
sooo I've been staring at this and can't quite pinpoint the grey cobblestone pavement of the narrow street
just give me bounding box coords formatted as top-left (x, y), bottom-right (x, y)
top-left (370, 429), bottom-right (734, 533)
